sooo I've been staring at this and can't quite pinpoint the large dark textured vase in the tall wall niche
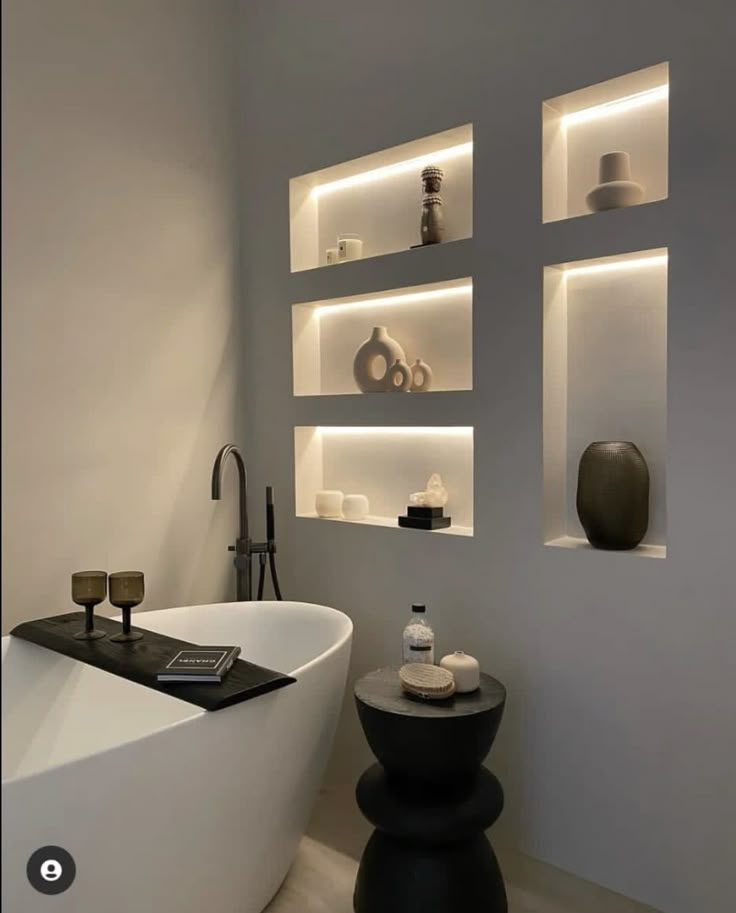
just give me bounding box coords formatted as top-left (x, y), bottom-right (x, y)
top-left (577, 441), bottom-right (649, 551)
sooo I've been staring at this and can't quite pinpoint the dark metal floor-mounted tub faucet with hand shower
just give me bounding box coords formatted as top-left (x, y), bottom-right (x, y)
top-left (212, 444), bottom-right (281, 602)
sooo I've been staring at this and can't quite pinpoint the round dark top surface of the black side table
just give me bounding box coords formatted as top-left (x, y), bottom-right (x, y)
top-left (354, 667), bottom-right (506, 719)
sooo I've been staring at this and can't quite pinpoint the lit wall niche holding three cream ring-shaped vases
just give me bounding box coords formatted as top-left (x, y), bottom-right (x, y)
top-left (291, 279), bottom-right (473, 396)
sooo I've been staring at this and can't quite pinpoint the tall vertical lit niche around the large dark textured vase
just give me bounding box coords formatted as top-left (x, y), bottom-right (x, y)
top-left (543, 248), bottom-right (667, 558)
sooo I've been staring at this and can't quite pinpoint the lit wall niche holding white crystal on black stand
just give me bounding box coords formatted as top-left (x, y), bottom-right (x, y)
top-left (294, 426), bottom-right (473, 536)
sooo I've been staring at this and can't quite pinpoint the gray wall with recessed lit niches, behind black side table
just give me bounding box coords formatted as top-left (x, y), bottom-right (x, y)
top-left (240, 0), bottom-right (736, 913)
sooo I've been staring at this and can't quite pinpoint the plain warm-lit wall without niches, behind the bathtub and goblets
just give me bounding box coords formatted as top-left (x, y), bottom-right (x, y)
top-left (2, 0), bottom-right (241, 630)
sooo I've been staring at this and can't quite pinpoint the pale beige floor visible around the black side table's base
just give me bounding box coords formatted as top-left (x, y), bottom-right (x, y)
top-left (264, 837), bottom-right (656, 913)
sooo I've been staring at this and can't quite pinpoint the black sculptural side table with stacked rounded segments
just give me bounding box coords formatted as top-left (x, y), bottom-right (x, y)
top-left (353, 669), bottom-right (507, 913)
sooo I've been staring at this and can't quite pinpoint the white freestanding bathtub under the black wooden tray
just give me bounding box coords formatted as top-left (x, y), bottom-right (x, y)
top-left (2, 602), bottom-right (352, 913)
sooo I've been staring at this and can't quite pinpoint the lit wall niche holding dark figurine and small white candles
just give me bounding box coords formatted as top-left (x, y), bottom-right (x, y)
top-left (289, 124), bottom-right (473, 272)
